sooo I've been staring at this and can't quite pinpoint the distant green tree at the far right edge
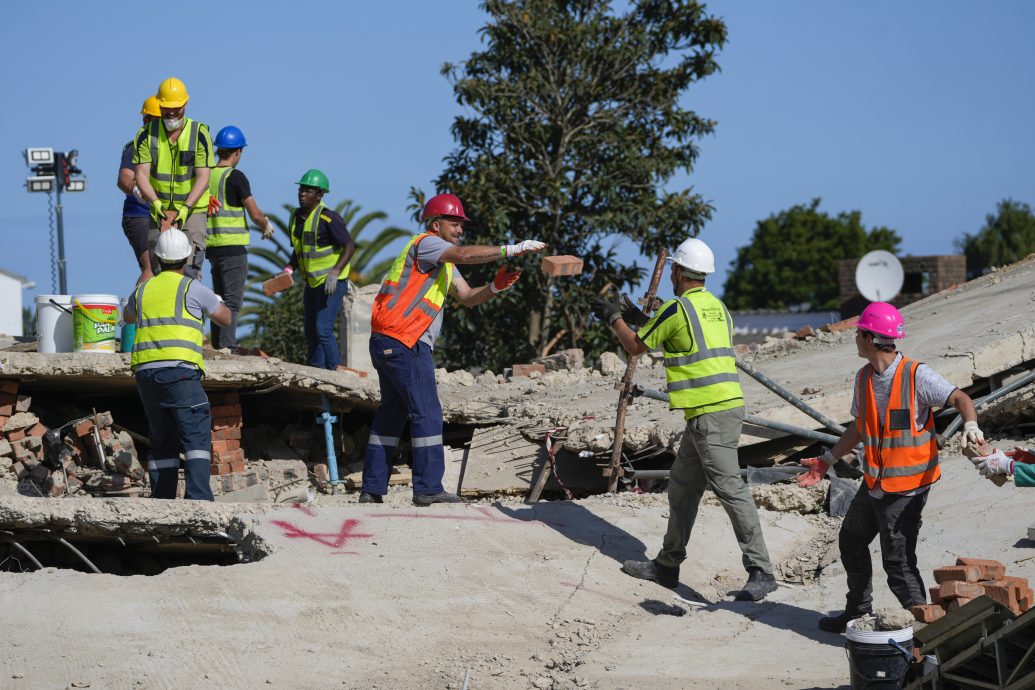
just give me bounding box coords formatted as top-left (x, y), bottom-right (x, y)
top-left (955, 199), bottom-right (1035, 275)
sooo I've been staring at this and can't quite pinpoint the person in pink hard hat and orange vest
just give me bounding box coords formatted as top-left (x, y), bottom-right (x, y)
top-left (798, 302), bottom-right (984, 633)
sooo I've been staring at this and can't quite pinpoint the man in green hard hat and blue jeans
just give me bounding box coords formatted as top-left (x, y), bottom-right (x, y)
top-left (285, 168), bottom-right (356, 369)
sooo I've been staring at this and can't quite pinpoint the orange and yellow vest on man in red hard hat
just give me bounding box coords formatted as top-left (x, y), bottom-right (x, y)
top-left (371, 233), bottom-right (452, 348)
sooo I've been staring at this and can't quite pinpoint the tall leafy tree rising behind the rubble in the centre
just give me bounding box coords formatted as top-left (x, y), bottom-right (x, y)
top-left (428, 0), bottom-right (727, 369)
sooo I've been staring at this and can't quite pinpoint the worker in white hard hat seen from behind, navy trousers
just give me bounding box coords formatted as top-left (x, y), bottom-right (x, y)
top-left (123, 228), bottom-right (231, 501)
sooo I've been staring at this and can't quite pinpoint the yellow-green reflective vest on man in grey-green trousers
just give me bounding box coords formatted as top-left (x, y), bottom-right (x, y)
top-left (664, 289), bottom-right (744, 409)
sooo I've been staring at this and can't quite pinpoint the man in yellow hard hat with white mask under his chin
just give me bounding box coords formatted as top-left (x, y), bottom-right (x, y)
top-left (134, 77), bottom-right (215, 279)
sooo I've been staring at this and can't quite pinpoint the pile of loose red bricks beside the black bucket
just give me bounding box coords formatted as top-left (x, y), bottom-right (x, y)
top-left (910, 558), bottom-right (1035, 623)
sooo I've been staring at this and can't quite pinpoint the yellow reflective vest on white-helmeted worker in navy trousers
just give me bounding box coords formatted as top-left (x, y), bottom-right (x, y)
top-left (130, 271), bottom-right (205, 371)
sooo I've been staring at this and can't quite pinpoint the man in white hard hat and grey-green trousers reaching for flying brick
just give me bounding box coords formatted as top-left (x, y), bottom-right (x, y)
top-left (594, 238), bottom-right (776, 601)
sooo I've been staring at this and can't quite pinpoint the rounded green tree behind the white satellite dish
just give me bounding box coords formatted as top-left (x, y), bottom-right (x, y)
top-left (722, 199), bottom-right (901, 309)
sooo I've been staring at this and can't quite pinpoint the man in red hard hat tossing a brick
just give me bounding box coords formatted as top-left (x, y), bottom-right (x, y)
top-left (359, 194), bottom-right (546, 506)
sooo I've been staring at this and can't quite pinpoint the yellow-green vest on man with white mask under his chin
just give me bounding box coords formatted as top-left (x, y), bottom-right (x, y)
top-left (147, 117), bottom-right (209, 212)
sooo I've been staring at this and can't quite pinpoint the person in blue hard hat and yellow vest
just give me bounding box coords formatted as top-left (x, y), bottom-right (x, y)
top-left (205, 125), bottom-right (273, 351)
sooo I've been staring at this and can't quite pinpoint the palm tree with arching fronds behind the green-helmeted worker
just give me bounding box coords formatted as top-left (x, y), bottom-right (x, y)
top-left (240, 200), bottom-right (411, 364)
